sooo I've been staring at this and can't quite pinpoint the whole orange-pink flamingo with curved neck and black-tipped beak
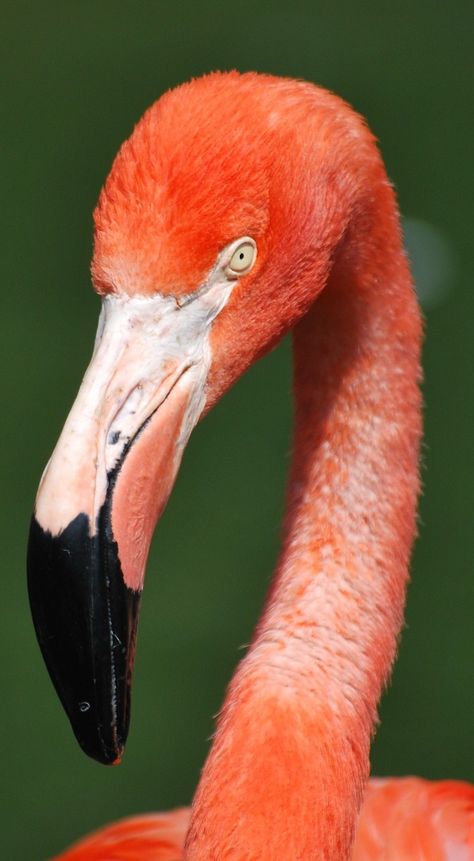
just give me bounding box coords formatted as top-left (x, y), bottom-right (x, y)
top-left (28, 72), bottom-right (474, 861)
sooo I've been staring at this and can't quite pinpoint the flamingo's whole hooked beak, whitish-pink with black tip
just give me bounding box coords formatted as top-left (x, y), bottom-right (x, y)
top-left (27, 296), bottom-right (213, 764)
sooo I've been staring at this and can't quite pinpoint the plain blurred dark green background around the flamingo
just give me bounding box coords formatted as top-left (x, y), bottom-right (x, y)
top-left (0, 0), bottom-right (474, 861)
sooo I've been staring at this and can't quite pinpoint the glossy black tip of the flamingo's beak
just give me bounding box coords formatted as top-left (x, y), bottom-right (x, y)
top-left (27, 514), bottom-right (141, 765)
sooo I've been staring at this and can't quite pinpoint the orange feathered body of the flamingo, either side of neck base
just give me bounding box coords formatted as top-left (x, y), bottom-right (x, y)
top-left (57, 777), bottom-right (474, 861)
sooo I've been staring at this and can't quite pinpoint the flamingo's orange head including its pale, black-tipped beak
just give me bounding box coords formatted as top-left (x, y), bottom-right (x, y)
top-left (28, 73), bottom-right (368, 763)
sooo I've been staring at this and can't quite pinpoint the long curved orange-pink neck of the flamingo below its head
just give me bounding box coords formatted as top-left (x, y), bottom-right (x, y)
top-left (185, 187), bottom-right (420, 861)
